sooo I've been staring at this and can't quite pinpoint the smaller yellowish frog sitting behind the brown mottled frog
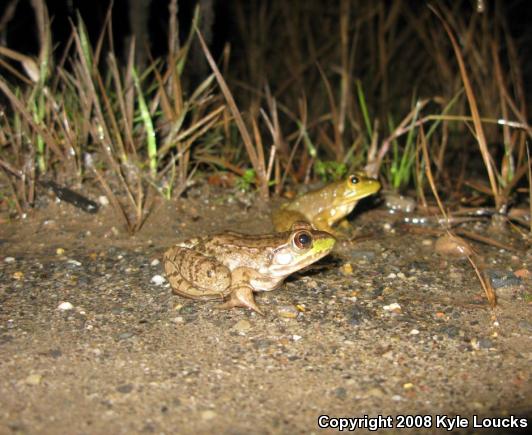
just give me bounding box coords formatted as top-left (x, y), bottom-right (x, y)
top-left (272, 172), bottom-right (381, 237)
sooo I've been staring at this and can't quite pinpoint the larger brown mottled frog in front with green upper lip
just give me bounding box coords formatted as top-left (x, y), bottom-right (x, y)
top-left (163, 221), bottom-right (336, 315)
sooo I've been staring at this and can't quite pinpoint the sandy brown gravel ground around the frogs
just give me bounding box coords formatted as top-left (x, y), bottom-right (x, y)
top-left (0, 199), bottom-right (532, 434)
